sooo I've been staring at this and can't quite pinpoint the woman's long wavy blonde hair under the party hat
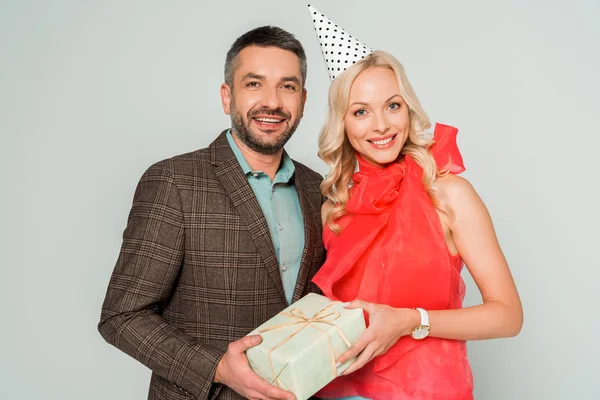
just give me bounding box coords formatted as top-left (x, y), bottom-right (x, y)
top-left (318, 51), bottom-right (452, 233)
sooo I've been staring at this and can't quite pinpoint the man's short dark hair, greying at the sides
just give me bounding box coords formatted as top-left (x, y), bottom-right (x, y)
top-left (225, 26), bottom-right (306, 88)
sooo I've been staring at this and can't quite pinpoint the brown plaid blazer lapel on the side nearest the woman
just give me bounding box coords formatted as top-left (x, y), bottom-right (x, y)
top-left (292, 168), bottom-right (321, 302)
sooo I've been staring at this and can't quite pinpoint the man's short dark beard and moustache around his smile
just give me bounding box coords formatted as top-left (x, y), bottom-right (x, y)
top-left (231, 99), bottom-right (302, 154)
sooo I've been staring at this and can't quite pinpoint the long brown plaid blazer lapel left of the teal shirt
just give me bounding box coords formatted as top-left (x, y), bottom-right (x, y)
top-left (209, 131), bottom-right (287, 303)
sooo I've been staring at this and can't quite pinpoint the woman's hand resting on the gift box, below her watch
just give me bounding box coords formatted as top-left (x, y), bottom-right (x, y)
top-left (337, 300), bottom-right (421, 375)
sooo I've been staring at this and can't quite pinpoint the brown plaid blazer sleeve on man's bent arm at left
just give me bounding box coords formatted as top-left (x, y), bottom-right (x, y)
top-left (98, 160), bottom-right (224, 399)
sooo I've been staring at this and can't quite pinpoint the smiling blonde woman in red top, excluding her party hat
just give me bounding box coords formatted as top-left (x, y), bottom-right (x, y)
top-left (313, 51), bottom-right (522, 400)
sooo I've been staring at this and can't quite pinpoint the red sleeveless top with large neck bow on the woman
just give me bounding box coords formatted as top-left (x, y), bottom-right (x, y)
top-left (313, 124), bottom-right (473, 400)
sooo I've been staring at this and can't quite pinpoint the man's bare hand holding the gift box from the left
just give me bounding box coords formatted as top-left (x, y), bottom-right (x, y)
top-left (214, 335), bottom-right (296, 400)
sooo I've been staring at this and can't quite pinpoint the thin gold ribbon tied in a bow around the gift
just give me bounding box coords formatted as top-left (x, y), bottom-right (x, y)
top-left (258, 302), bottom-right (352, 387)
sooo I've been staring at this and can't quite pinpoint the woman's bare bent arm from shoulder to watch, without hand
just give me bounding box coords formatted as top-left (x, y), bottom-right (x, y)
top-left (428, 175), bottom-right (523, 340)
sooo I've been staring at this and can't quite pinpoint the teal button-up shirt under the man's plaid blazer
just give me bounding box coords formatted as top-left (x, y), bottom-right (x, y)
top-left (227, 130), bottom-right (304, 304)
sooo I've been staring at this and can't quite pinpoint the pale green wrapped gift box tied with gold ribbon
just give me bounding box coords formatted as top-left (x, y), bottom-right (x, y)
top-left (246, 294), bottom-right (366, 400)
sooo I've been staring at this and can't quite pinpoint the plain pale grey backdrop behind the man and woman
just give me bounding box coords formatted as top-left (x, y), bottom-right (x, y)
top-left (0, 0), bottom-right (600, 400)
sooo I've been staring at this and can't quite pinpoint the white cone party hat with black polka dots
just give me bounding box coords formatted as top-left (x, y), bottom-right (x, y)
top-left (308, 5), bottom-right (373, 81)
